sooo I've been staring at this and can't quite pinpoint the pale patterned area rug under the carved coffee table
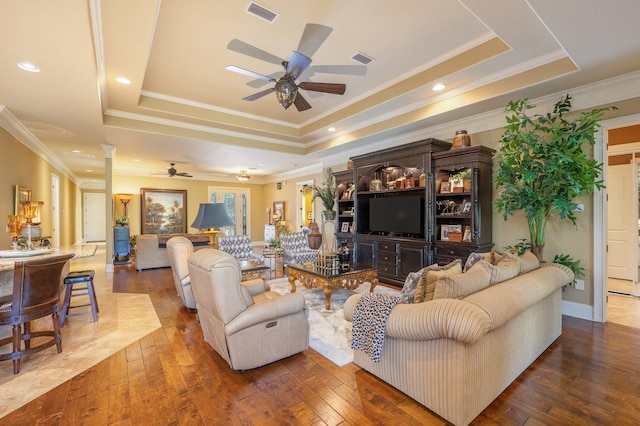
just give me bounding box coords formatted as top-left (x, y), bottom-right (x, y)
top-left (268, 278), bottom-right (398, 367)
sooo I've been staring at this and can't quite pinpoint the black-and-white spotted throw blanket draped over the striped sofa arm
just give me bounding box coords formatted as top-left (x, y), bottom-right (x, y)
top-left (351, 293), bottom-right (404, 362)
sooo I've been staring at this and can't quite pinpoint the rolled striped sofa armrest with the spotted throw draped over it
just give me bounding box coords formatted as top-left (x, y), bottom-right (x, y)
top-left (344, 294), bottom-right (491, 343)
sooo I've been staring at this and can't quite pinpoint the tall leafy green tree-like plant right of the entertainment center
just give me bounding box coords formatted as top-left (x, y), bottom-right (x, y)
top-left (494, 95), bottom-right (616, 260)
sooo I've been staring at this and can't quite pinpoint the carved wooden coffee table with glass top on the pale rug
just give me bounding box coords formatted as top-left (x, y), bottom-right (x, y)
top-left (286, 263), bottom-right (378, 310)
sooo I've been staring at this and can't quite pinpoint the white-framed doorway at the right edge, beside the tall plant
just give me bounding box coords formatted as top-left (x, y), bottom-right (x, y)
top-left (593, 114), bottom-right (640, 327)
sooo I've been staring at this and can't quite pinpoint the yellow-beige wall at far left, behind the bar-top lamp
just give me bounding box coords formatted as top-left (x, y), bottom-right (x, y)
top-left (0, 128), bottom-right (81, 250)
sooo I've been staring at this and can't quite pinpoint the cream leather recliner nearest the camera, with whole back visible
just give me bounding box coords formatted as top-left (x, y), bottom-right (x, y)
top-left (188, 249), bottom-right (309, 370)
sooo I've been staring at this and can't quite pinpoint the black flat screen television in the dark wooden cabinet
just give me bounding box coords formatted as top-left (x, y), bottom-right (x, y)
top-left (369, 196), bottom-right (424, 237)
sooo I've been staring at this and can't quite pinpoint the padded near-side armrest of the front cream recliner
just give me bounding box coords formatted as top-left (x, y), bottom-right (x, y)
top-left (225, 293), bottom-right (306, 336)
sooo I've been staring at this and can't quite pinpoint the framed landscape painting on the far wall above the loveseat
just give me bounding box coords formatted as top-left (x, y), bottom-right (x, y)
top-left (140, 188), bottom-right (187, 234)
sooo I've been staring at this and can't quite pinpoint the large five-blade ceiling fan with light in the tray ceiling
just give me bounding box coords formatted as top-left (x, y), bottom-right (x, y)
top-left (226, 24), bottom-right (347, 111)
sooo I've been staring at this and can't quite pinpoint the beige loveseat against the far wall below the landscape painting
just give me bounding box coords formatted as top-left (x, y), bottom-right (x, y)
top-left (136, 234), bottom-right (209, 271)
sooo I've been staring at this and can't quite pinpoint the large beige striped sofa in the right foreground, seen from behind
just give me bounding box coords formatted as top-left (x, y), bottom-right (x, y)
top-left (344, 264), bottom-right (574, 425)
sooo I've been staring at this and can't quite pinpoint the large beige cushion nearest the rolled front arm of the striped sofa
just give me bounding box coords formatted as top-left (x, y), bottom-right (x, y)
top-left (433, 260), bottom-right (493, 300)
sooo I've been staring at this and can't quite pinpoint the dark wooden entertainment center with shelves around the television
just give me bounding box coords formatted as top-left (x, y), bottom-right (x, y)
top-left (334, 138), bottom-right (494, 286)
